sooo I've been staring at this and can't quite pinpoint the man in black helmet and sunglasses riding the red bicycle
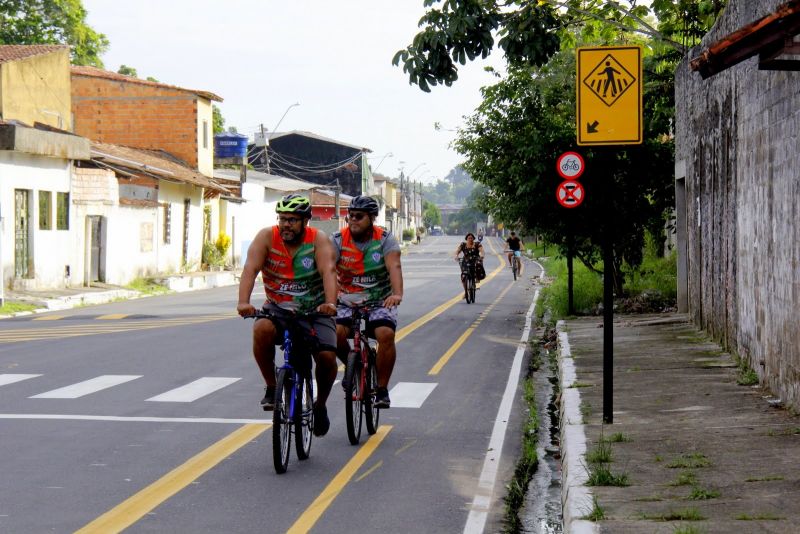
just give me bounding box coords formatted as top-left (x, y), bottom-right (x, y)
top-left (331, 195), bottom-right (403, 408)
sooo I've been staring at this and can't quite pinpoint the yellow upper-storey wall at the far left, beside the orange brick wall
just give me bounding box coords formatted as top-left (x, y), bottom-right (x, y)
top-left (0, 48), bottom-right (72, 130)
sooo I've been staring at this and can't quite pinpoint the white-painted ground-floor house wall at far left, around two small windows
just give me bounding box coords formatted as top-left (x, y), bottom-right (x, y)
top-left (0, 150), bottom-right (72, 289)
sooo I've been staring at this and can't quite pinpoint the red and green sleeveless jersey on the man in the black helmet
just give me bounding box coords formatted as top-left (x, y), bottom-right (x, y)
top-left (336, 226), bottom-right (392, 303)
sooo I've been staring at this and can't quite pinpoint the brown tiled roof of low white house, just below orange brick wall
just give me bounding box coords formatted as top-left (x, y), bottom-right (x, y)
top-left (91, 142), bottom-right (230, 194)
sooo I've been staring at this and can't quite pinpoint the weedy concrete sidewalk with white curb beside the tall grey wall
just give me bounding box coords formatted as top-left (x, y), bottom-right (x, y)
top-left (559, 314), bottom-right (800, 534)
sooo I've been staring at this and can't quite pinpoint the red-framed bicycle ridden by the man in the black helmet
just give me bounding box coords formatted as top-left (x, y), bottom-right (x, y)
top-left (344, 305), bottom-right (380, 445)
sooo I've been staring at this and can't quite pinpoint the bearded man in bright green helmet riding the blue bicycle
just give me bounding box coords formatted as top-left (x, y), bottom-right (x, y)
top-left (236, 194), bottom-right (337, 436)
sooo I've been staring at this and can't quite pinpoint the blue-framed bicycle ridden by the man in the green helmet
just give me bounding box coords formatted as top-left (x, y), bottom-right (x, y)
top-left (247, 311), bottom-right (314, 474)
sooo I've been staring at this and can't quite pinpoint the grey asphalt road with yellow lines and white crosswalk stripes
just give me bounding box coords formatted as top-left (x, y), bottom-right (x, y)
top-left (0, 237), bottom-right (540, 533)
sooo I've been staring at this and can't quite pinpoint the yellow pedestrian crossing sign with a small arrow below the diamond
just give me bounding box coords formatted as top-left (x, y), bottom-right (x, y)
top-left (575, 45), bottom-right (642, 145)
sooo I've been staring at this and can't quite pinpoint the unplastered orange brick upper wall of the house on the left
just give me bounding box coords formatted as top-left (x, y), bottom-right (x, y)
top-left (72, 74), bottom-right (198, 168)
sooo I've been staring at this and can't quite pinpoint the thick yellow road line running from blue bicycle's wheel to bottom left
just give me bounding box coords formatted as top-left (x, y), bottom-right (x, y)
top-left (76, 423), bottom-right (270, 534)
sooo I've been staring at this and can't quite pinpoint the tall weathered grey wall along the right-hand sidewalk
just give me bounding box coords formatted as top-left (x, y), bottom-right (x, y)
top-left (675, 0), bottom-right (800, 407)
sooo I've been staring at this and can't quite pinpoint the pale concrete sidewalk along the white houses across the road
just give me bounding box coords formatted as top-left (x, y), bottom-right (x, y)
top-left (0, 271), bottom-right (239, 318)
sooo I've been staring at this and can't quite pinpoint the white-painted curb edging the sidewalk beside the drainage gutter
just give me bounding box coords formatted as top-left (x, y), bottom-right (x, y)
top-left (556, 320), bottom-right (600, 534)
